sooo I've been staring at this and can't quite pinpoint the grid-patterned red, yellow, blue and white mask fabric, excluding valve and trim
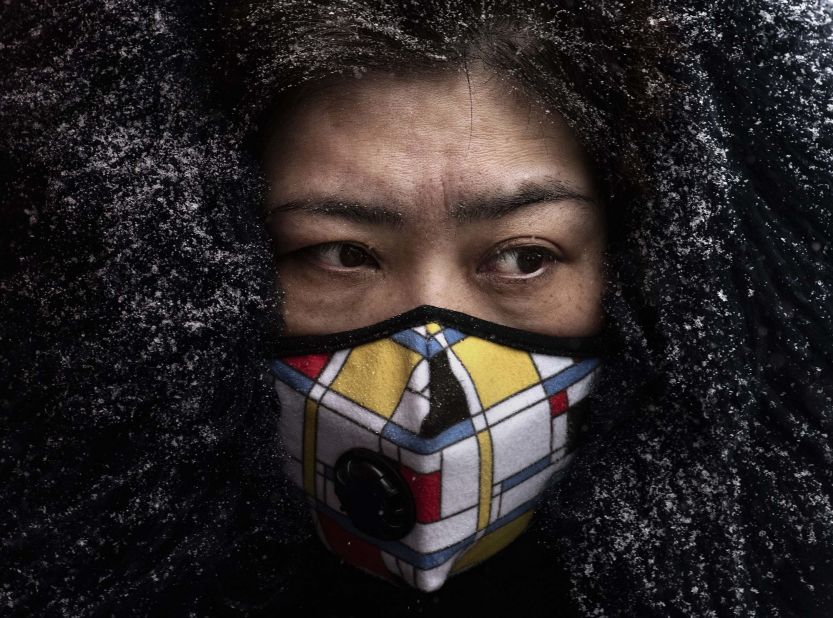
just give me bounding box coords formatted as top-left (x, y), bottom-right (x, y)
top-left (272, 324), bottom-right (598, 589)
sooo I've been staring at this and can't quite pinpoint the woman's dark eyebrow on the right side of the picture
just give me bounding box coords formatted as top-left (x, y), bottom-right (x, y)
top-left (449, 179), bottom-right (598, 223)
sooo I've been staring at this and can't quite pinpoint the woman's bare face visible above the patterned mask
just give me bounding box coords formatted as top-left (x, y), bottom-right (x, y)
top-left (266, 73), bottom-right (604, 336)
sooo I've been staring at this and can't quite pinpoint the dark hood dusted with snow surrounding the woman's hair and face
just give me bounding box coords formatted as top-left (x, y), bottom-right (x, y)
top-left (0, 0), bottom-right (833, 616)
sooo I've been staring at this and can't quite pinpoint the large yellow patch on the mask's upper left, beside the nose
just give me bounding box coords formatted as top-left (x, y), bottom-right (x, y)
top-left (331, 339), bottom-right (422, 418)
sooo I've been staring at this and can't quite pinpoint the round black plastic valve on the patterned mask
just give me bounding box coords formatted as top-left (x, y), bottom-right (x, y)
top-left (335, 448), bottom-right (416, 541)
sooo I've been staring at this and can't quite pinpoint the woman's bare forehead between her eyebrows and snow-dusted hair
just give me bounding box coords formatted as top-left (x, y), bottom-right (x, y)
top-left (266, 72), bottom-right (592, 216)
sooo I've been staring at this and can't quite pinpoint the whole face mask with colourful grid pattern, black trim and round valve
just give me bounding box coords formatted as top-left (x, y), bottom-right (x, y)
top-left (271, 307), bottom-right (600, 591)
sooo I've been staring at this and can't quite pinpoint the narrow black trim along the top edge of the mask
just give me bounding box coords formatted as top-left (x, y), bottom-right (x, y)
top-left (267, 305), bottom-right (608, 357)
